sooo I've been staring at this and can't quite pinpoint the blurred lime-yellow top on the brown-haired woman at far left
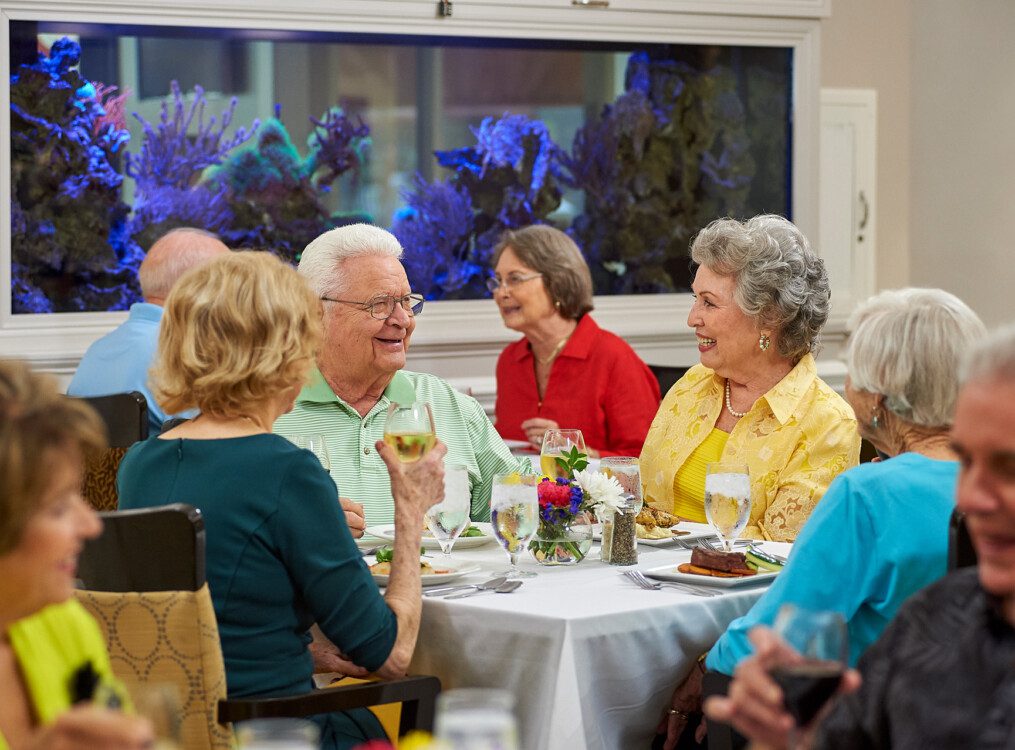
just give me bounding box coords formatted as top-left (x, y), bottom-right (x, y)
top-left (0, 599), bottom-right (118, 750)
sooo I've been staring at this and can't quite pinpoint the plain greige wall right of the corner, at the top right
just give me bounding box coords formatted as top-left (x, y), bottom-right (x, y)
top-left (909, 0), bottom-right (1015, 326)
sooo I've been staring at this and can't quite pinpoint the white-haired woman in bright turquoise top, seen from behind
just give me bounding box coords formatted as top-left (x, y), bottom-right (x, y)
top-left (660, 288), bottom-right (986, 748)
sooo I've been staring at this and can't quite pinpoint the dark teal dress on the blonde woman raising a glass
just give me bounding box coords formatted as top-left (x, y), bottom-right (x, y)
top-left (118, 434), bottom-right (389, 747)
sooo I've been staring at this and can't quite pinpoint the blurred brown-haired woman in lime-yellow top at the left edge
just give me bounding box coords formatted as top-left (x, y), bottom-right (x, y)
top-left (0, 360), bottom-right (153, 750)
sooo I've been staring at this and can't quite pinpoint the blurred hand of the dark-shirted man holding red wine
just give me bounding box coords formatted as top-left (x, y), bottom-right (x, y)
top-left (704, 627), bottom-right (860, 748)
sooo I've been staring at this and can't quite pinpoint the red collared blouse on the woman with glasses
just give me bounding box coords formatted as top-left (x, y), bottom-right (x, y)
top-left (496, 315), bottom-right (659, 456)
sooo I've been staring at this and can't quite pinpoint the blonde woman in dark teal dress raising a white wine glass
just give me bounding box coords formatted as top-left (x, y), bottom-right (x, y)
top-left (118, 252), bottom-right (446, 748)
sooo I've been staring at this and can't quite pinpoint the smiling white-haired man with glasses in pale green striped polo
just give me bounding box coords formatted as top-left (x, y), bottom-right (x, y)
top-left (274, 224), bottom-right (519, 536)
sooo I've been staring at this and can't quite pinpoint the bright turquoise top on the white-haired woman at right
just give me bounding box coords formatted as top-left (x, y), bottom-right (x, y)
top-left (705, 454), bottom-right (958, 675)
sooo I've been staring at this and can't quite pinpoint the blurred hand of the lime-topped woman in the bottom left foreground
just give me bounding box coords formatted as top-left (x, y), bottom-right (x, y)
top-left (28, 704), bottom-right (155, 750)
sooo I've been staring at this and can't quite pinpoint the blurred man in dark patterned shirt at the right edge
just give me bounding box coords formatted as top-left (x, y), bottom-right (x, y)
top-left (705, 326), bottom-right (1015, 750)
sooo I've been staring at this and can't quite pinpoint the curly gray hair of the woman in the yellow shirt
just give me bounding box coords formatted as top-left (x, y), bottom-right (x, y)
top-left (691, 214), bottom-right (831, 361)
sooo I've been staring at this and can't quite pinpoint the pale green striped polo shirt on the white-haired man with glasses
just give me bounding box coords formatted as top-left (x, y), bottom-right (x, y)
top-left (274, 367), bottom-right (528, 526)
